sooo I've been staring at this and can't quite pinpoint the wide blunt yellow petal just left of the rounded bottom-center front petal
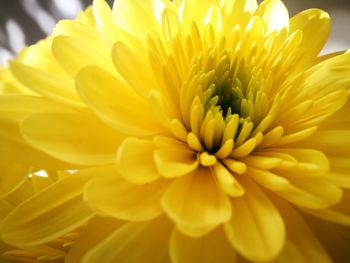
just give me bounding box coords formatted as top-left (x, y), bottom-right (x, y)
top-left (85, 175), bottom-right (169, 221)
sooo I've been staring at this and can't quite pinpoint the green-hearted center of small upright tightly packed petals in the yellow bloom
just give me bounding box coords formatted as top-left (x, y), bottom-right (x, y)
top-left (181, 46), bottom-right (270, 166)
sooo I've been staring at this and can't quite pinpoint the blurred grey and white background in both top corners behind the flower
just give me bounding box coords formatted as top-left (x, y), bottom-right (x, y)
top-left (0, 0), bottom-right (350, 64)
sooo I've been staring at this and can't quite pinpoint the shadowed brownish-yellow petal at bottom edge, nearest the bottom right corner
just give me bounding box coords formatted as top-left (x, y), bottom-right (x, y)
top-left (276, 201), bottom-right (332, 263)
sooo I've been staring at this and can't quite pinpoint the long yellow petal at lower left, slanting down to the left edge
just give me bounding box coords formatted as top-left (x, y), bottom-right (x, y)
top-left (0, 167), bottom-right (113, 246)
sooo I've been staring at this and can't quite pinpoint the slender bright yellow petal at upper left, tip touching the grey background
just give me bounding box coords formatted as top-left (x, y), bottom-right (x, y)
top-left (11, 61), bottom-right (84, 107)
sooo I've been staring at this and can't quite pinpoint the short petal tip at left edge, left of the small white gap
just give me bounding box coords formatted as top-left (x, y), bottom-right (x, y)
top-left (0, 160), bottom-right (29, 198)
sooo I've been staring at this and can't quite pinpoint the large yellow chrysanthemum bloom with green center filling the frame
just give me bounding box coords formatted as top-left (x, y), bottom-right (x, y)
top-left (1, 0), bottom-right (350, 263)
